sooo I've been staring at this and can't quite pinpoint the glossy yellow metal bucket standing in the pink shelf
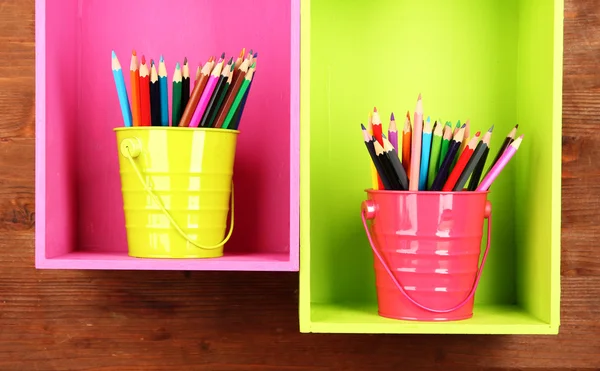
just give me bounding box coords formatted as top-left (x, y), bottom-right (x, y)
top-left (114, 126), bottom-right (239, 258)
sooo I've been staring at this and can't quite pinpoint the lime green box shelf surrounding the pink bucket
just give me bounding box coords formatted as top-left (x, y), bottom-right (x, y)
top-left (300, 0), bottom-right (564, 334)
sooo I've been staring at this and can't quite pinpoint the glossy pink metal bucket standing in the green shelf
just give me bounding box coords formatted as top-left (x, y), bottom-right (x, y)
top-left (361, 189), bottom-right (492, 321)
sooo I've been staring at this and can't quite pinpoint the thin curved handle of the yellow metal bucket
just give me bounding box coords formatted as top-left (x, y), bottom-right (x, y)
top-left (121, 138), bottom-right (234, 250)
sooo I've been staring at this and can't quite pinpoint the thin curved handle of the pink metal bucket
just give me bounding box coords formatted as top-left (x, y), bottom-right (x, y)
top-left (361, 201), bottom-right (492, 313)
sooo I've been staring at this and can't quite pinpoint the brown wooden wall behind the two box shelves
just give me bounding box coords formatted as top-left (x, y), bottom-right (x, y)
top-left (0, 0), bottom-right (600, 371)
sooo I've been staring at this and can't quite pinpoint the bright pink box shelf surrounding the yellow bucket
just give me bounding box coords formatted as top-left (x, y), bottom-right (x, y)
top-left (35, 0), bottom-right (300, 271)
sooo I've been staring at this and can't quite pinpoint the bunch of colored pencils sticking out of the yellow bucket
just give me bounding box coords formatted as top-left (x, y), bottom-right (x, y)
top-left (112, 49), bottom-right (258, 130)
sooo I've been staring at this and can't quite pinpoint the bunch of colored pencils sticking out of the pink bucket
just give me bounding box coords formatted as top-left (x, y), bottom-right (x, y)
top-left (361, 94), bottom-right (523, 192)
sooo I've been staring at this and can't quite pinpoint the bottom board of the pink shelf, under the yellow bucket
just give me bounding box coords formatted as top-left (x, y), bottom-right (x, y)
top-left (36, 251), bottom-right (297, 271)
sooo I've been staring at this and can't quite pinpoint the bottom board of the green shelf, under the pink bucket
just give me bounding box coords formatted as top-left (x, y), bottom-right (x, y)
top-left (301, 303), bottom-right (558, 334)
